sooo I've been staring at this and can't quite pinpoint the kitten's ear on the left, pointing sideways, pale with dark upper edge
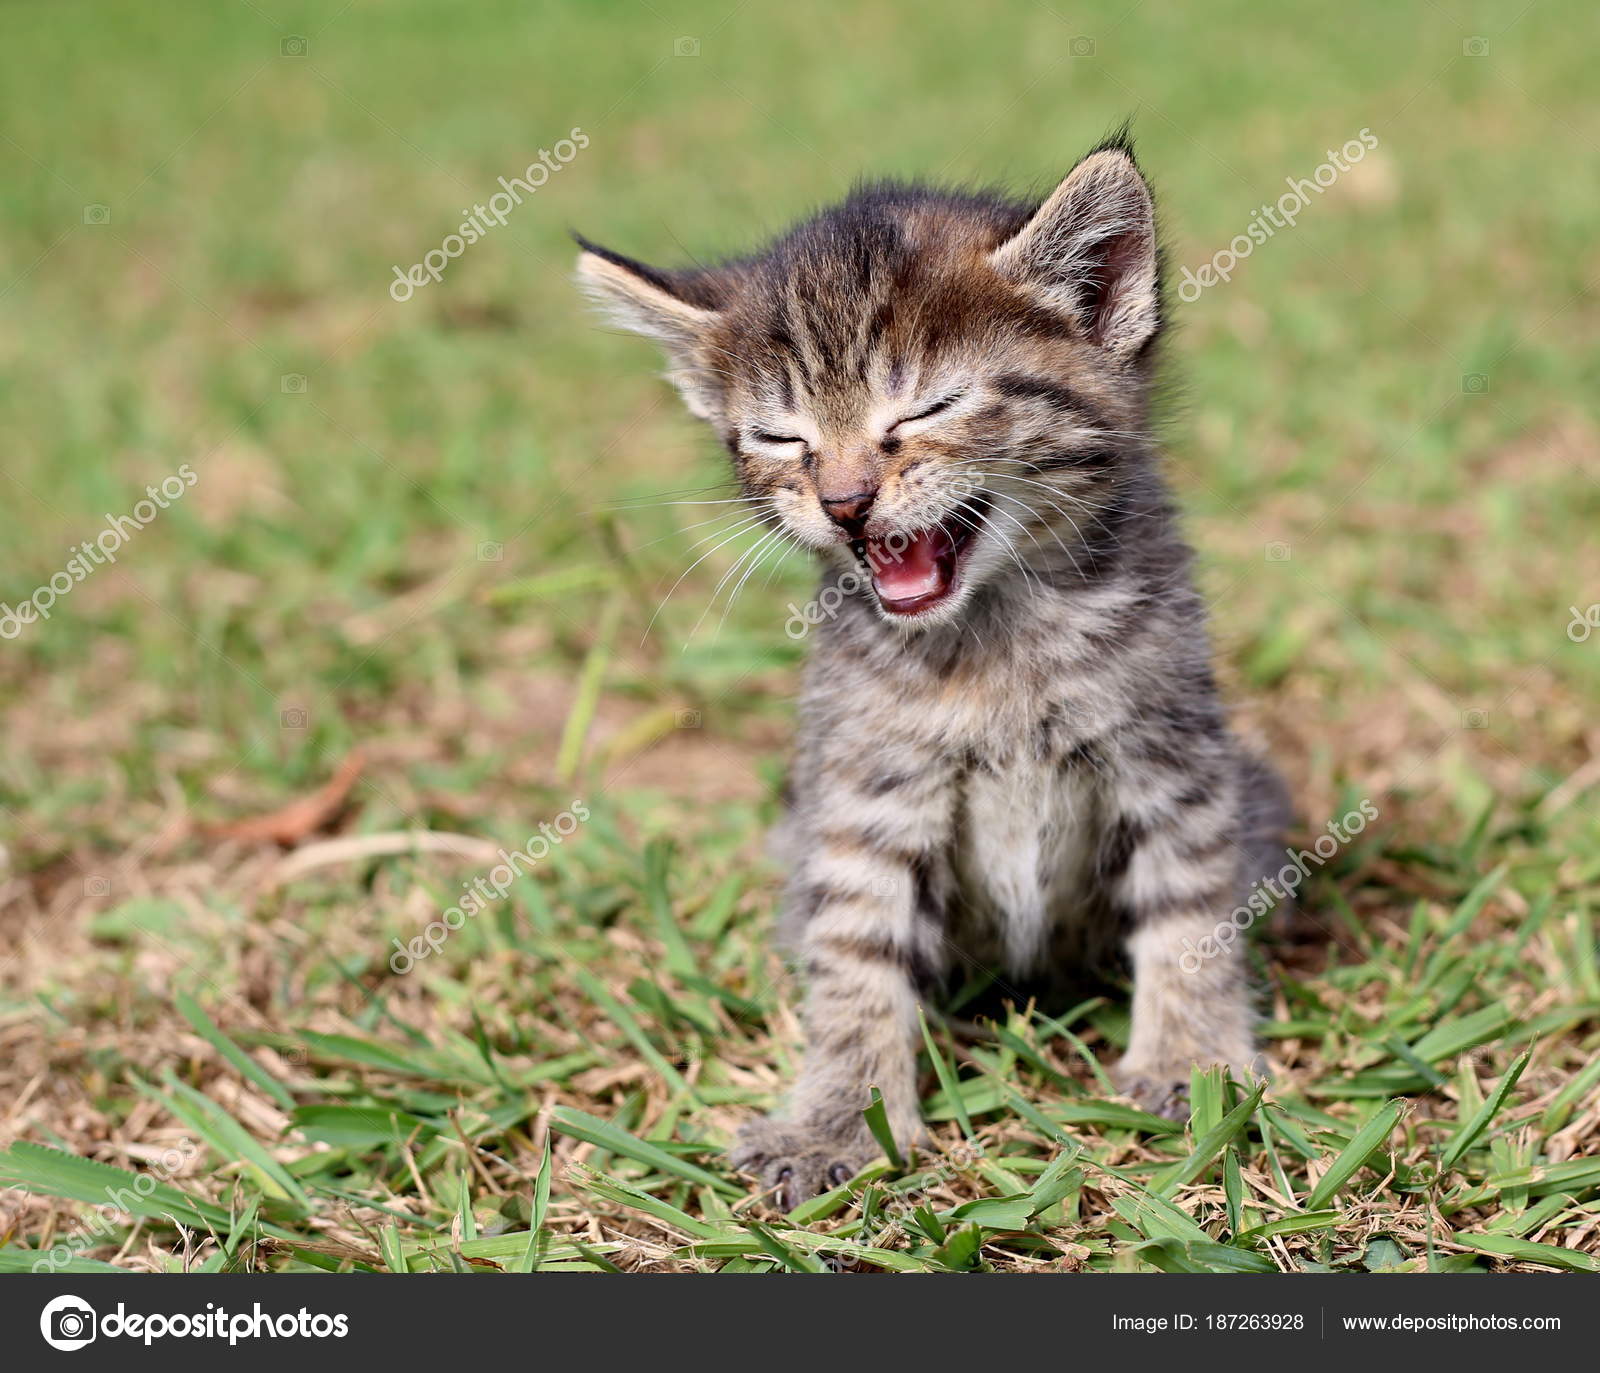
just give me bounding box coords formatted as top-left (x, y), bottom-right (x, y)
top-left (573, 234), bottom-right (722, 419)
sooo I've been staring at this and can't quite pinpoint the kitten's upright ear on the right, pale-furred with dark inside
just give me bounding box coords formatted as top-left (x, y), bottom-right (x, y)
top-left (989, 146), bottom-right (1162, 357)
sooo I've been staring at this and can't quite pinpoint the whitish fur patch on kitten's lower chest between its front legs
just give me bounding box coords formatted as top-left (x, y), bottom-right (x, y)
top-left (952, 751), bottom-right (1099, 976)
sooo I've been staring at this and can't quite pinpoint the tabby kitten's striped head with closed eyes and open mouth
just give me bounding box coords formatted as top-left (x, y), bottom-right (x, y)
top-left (578, 139), bottom-right (1162, 627)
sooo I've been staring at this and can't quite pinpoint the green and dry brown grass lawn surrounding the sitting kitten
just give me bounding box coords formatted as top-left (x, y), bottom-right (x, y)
top-left (0, 0), bottom-right (1600, 1272)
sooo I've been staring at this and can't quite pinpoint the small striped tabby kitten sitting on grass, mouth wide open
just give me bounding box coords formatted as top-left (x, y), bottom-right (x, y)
top-left (578, 136), bottom-right (1283, 1207)
